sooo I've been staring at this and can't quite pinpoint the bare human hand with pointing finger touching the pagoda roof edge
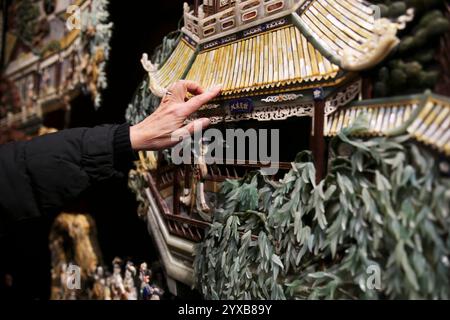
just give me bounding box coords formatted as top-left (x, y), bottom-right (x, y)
top-left (130, 80), bottom-right (222, 151)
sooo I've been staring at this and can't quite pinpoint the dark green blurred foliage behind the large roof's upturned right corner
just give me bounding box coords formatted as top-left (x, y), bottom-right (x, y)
top-left (370, 0), bottom-right (450, 97)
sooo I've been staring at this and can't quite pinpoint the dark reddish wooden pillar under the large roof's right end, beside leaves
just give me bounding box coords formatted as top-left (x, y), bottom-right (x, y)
top-left (311, 89), bottom-right (325, 183)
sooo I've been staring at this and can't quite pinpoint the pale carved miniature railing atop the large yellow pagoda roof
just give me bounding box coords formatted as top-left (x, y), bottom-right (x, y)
top-left (184, 0), bottom-right (303, 39)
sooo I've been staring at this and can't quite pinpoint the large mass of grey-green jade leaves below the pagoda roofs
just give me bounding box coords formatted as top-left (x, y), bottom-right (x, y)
top-left (194, 122), bottom-right (450, 299)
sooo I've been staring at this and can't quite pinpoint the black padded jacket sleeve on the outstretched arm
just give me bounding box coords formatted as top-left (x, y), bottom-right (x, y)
top-left (0, 124), bottom-right (134, 235)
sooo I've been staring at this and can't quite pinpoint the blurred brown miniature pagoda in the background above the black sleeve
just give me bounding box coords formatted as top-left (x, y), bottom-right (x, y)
top-left (0, 0), bottom-right (112, 136)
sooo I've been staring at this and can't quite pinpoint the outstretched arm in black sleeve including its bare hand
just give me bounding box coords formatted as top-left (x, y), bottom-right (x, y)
top-left (0, 81), bottom-right (221, 238)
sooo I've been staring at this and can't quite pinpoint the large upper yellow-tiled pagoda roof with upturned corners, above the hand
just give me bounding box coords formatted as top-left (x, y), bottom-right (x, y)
top-left (143, 0), bottom-right (408, 97)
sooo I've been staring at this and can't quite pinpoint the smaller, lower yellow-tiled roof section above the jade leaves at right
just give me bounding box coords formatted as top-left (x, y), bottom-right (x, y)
top-left (325, 93), bottom-right (450, 156)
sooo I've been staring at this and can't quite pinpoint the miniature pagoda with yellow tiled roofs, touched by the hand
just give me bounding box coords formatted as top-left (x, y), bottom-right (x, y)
top-left (127, 0), bottom-right (450, 293)
